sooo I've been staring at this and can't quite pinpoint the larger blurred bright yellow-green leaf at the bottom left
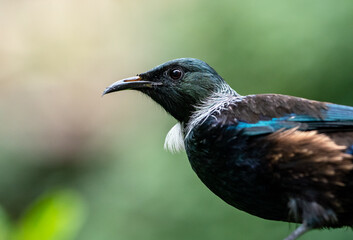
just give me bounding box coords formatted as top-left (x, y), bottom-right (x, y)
top-left (15, 190), bottom-right (86, 240)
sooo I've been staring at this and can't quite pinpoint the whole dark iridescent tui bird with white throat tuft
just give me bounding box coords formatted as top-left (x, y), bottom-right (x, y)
top-left (103, 58), bottom-right (353, 240)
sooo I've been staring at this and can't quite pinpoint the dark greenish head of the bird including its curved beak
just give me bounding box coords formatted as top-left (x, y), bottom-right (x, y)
top-left (103, 58), bottom-right (230, 122)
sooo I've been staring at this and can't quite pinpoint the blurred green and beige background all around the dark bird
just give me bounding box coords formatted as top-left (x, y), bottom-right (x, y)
top-left (0, 0), bottom-right (353, 240)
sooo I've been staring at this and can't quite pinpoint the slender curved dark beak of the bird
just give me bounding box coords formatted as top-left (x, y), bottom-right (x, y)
top-left (102, 75), bottom-right (162, 96)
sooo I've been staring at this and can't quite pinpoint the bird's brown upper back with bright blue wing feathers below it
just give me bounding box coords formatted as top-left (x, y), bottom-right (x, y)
top-left (194, 94), bottom-right (353, 135)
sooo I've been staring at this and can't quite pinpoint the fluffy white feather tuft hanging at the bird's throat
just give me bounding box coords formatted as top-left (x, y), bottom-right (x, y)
top-left (164, 123), bottom-right (185, 153)
